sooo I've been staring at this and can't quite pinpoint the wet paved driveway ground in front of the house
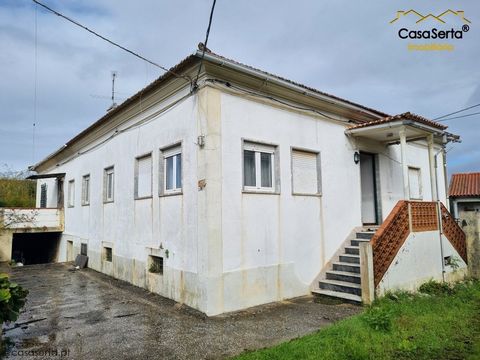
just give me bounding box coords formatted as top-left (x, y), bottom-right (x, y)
top-left (4, 264), bottom-right (361, 360)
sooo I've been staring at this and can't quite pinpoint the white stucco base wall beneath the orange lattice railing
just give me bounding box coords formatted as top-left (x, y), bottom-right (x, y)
top-left (377, 230), bottom-right (467, 295)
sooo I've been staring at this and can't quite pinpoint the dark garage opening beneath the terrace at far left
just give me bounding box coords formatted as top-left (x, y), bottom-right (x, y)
top-left (12, 232), bottom-right (61, 265)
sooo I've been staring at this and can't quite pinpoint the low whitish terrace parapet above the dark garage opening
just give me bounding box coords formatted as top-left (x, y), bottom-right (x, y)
top-left (0, 208), bottom-right (64, 232)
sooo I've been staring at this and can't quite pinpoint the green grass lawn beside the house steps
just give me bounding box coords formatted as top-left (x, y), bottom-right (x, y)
top-left (235, 280), bottom-right (480, 360)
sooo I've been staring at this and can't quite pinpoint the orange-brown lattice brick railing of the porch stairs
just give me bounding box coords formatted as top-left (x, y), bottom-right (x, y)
top-left (370, 200), bottom-right (467, 286)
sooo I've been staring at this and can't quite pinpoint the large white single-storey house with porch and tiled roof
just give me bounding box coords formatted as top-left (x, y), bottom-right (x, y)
top-left (0, 51), bottom-right (466, 315)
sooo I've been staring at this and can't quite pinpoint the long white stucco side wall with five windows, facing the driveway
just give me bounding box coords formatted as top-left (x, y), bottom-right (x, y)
top-left (37, 86), bottom-right (202, 308)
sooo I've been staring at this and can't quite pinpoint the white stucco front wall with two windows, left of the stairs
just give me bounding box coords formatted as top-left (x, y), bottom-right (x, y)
top-left (217, 93), bottom-right (361, 311)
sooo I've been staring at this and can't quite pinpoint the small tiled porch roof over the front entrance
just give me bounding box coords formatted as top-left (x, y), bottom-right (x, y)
top-left (345, 112), bottom-right (455, 142)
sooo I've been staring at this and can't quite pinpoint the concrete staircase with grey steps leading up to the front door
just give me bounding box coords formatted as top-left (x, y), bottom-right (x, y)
top-left (312, 228), bottom-right (376, 303)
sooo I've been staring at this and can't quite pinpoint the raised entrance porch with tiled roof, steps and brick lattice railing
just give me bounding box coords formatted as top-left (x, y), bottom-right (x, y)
top-left (312, 113), bottom-right (467, 303)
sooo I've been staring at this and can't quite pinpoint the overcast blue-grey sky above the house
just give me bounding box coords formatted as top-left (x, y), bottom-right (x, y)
top-left (0, 0), bottom-right (480, 173)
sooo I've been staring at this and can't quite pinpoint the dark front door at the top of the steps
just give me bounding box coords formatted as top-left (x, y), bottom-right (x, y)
top-left (360, 153), bottom-right (377, 225)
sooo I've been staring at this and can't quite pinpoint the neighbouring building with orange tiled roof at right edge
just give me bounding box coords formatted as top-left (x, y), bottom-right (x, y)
top-left (448, 172), bottom-right (480, 219)
